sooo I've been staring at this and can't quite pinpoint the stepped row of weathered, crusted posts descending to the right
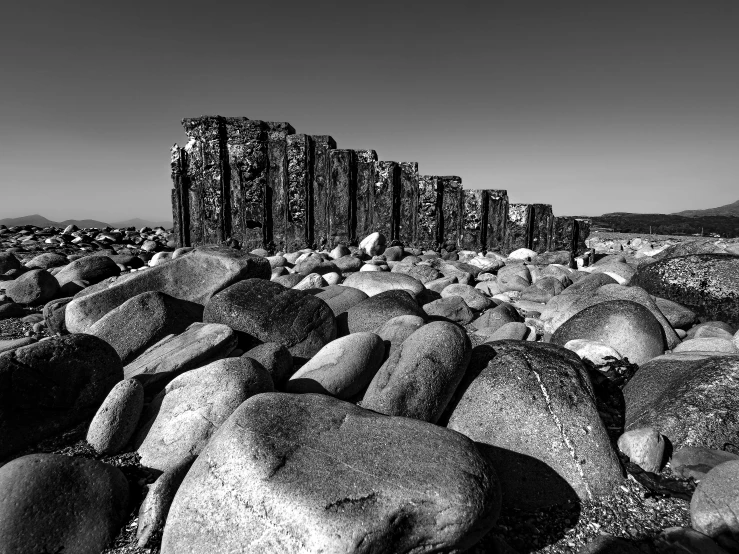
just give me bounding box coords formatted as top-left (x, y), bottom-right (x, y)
top-left (171, 116), bottom-right (589, 254)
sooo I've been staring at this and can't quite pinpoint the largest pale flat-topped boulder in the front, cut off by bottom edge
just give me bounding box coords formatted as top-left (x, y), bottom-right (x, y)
top-left (161, 394), bottom-right (500, 554)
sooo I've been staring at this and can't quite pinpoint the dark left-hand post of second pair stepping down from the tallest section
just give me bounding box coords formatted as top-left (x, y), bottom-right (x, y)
top-left (327, 150), bottom-right (357, 248)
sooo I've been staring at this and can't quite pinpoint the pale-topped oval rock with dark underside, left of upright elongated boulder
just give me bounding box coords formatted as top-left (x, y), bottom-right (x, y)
top-left (286, 332), bottom-right (385, 400)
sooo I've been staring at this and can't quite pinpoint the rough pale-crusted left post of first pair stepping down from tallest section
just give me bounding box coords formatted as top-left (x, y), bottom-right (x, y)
top-left (285, 134), bottom-right (313, 252)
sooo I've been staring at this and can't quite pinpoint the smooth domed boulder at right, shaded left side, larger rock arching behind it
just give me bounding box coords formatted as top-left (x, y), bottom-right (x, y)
top-left (551, 300), bottom-right (664, 365)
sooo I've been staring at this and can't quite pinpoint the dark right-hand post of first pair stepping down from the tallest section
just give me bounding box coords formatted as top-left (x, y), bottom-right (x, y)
top-left (308, 135), bottom-right (336, 250)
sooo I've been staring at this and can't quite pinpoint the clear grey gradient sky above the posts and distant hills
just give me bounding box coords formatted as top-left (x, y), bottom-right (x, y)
top-left (0, 0), bottom-right (739, 221)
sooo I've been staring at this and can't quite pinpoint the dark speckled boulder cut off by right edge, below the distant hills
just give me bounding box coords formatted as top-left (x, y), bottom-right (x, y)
top-left (632, 254), bottom-right (739, 326)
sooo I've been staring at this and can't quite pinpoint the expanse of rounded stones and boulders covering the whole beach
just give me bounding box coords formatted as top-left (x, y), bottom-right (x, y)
top-left (0, 221), bottom-right (739, 554)
